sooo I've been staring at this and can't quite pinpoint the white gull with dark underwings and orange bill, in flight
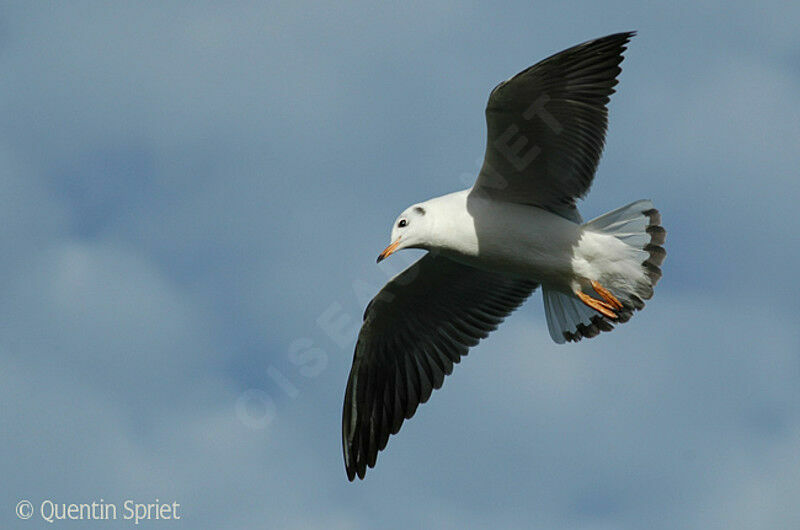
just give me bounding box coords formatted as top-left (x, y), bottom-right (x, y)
top-left (342, 32), bottom-right (666, 481)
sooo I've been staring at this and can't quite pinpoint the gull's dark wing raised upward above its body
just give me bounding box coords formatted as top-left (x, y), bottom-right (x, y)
top-left (475, 32), bottom-right (635, 219)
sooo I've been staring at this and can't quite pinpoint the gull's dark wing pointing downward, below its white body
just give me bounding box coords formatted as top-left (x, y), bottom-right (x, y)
top-left (342, 254), bottom-right (537, 480)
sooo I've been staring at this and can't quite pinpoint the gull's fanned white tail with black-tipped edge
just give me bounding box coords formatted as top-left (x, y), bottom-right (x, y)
top-left (542, 200), bottom-right (667, 344)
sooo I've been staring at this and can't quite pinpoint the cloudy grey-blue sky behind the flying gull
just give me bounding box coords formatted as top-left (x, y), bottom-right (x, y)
top-left (0, 2), bottom-right (800, 530)
